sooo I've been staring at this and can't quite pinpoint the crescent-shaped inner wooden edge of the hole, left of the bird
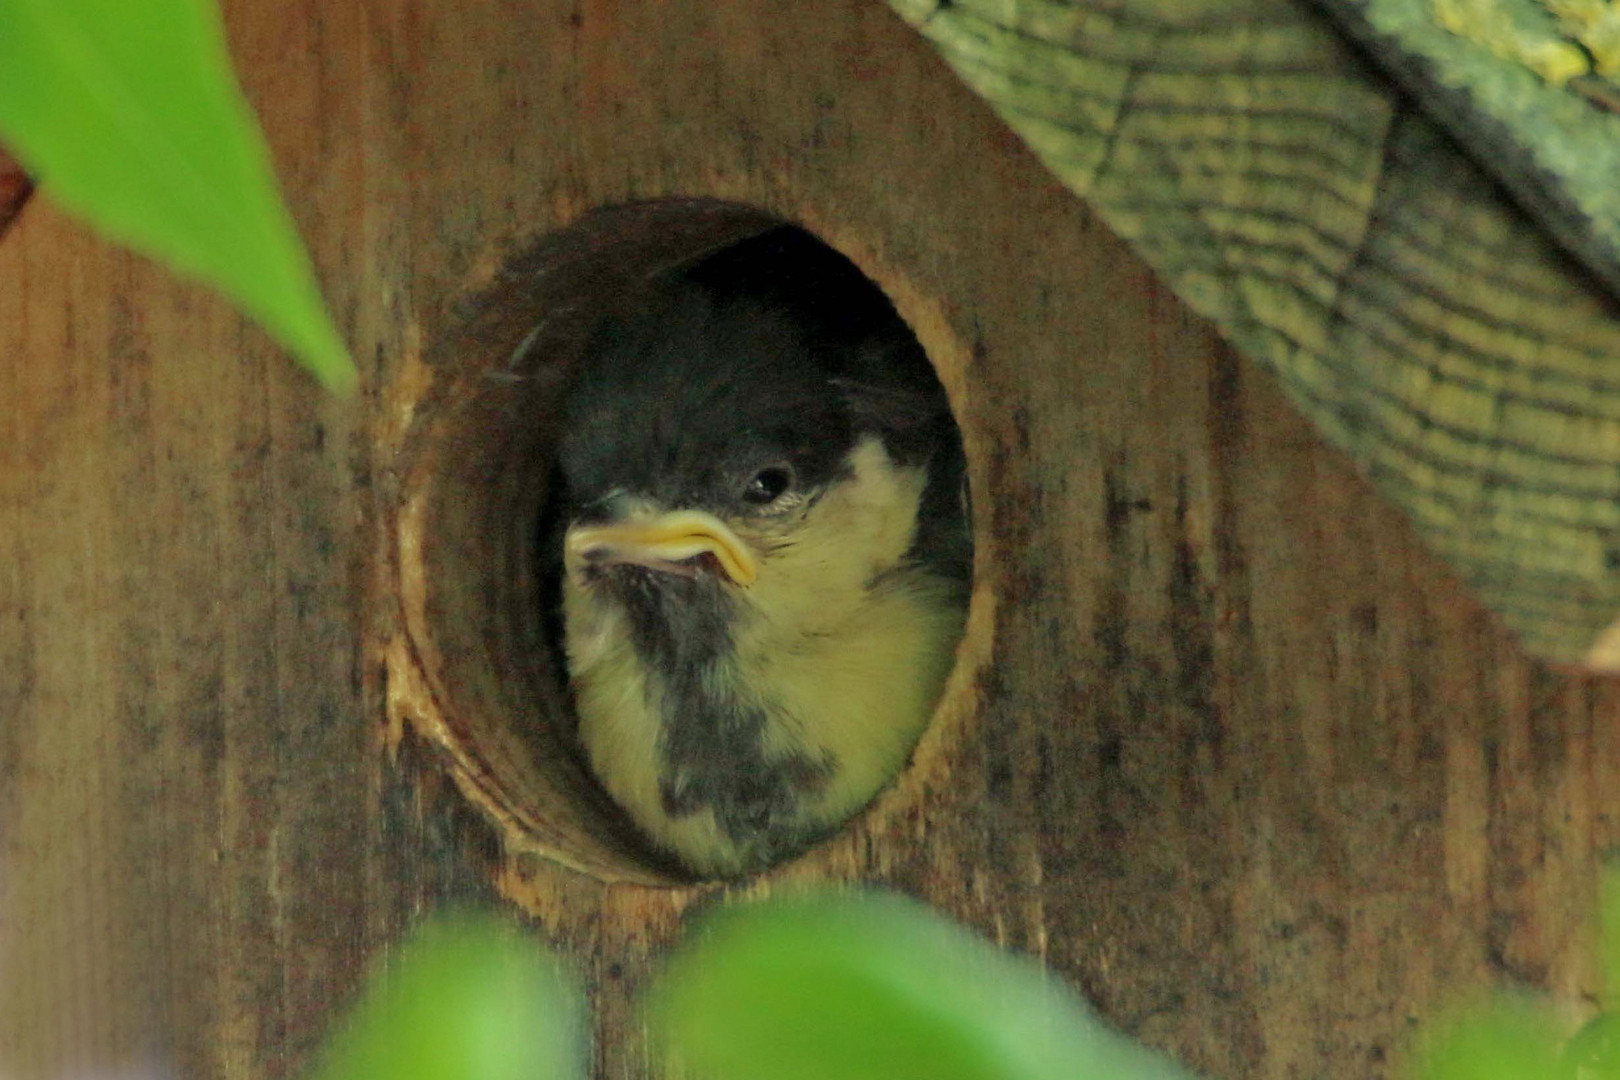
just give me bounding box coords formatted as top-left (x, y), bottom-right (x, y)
top-left (390, 201), bottom-right (972, 884)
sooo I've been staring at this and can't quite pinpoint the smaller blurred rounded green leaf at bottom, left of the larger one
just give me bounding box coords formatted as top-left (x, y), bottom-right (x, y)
top-left (314, 915), bottom-right (586, 1080)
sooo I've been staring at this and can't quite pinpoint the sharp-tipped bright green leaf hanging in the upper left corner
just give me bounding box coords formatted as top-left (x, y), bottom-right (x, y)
top-left (0, 0), bottom-right (356, 390)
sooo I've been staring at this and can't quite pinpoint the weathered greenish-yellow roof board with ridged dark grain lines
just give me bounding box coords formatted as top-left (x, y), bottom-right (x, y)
top-left (893, 0), bottom-right (1620, 669)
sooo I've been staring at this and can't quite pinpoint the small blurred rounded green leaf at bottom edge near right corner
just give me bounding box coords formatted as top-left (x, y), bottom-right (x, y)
top-left (1418, 999), bottom-right (1573, 1080)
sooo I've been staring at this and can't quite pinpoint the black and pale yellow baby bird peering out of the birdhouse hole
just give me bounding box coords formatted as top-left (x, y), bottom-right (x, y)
top-left (559, 227), bottom-right (972, 878)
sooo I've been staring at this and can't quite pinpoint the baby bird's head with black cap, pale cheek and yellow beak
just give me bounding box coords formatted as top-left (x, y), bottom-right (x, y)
top-left (561, 268), bottom-right (949, 615)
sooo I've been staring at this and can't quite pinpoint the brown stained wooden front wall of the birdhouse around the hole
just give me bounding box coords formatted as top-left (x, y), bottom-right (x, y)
top-left (0, 0), bottom-right (1620, 1080)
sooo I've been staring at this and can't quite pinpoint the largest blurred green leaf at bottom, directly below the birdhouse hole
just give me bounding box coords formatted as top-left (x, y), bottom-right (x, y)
top-left (648, 897), bottom-right (1186, 1080)
